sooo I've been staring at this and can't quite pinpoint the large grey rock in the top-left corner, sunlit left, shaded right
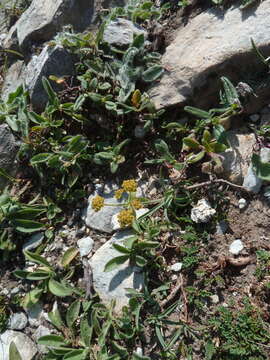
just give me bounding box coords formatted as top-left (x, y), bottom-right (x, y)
top-left (4, 0), bottom-right (94, 51)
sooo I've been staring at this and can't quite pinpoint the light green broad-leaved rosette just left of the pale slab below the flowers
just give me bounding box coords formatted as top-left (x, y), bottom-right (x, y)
top-left (14, 248), bottom-right (81, 308)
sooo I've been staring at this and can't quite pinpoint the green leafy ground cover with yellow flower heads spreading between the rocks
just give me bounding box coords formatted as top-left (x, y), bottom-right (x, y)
top-left (0, 0), bottom-right (270, 360)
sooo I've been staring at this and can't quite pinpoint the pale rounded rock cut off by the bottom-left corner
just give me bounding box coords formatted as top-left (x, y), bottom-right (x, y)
top-left (0, 330), bottom-right (37, 360)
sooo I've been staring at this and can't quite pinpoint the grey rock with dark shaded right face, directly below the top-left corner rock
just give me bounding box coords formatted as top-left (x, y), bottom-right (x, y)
top-left (2, 45), bottom-right (75, 111)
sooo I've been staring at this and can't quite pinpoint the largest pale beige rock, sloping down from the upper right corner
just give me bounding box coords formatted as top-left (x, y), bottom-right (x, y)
top-left (150, 0), bottom-right (270, 109)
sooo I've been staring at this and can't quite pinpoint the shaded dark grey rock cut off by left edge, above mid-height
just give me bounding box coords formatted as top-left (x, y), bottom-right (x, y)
top-left (0, 124), bottom-right (19, 190)
